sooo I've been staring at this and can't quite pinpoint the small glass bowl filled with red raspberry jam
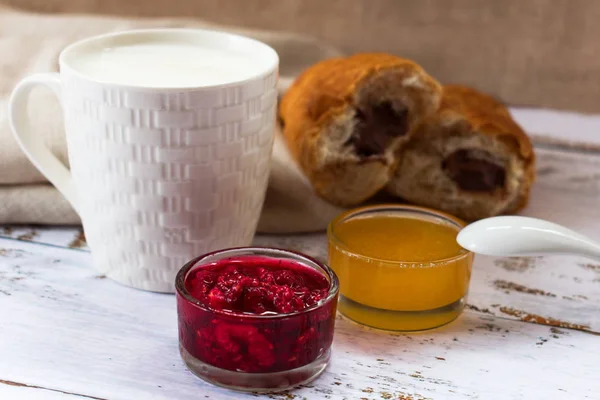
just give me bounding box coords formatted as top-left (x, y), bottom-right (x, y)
top-left (175, 247), bottom-right (339, 392)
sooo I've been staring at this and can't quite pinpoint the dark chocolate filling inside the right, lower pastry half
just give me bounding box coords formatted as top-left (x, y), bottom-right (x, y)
top-left (442, 150), bottom-right (506, 192)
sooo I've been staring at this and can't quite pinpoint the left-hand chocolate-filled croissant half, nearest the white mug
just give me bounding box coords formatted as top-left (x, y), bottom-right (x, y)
top-left (279, 53), bottom-right (442, 206)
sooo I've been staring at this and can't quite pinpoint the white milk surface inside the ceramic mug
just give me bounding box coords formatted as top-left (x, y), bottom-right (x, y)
top-left (69, 41), bottom-right (260, 88)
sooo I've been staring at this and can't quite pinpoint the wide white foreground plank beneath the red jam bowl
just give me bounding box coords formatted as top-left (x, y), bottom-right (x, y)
top-left (0, 239), bottom-right (600, 400)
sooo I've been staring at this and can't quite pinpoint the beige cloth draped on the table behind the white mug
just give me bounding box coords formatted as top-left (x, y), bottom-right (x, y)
top-left (0, 6), bottom-right (340, 232)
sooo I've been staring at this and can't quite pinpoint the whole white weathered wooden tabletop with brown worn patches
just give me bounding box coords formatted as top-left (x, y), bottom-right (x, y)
top-left (0, 110), bottom-right (600, 400)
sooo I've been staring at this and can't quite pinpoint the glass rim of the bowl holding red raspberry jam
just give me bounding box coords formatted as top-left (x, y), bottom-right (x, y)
top-left (175, 246), bottom-right (340, 320)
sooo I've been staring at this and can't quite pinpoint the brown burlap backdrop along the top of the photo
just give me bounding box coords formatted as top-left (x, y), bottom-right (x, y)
top-left (0, 0), bottom-right (600, 112)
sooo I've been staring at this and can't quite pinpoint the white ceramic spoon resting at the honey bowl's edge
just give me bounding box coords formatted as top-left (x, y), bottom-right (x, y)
top-left (456, 216), bottom-right (600, 261)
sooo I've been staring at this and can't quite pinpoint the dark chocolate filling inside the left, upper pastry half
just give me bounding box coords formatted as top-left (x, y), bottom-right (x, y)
top-left (346, 102), bottom-right (408, 158)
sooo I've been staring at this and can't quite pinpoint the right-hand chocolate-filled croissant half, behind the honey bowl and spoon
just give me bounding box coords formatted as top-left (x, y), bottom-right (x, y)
top-left (387, 85), bottom-right (535, 220)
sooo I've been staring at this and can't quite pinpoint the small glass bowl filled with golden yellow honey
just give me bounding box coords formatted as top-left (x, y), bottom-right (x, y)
top-left (327, 205), bottom-right (473, 331)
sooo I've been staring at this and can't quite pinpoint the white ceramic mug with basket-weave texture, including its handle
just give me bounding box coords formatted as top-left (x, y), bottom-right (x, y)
top-left (9, 29), bottom-right (279, 292)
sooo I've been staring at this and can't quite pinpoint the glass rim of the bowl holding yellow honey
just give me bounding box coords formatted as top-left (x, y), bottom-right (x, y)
top-left (327, 204), bottom-right (473, 266)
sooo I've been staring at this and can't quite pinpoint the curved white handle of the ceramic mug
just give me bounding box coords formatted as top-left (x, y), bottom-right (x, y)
top-left (8, 73), bottom-right (77, 211)
